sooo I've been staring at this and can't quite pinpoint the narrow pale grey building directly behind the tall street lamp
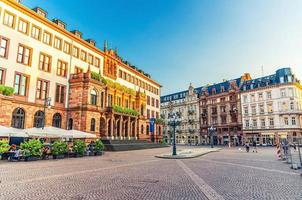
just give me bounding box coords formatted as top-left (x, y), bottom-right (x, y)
top-left (161, 84), bottom-right (200, 145)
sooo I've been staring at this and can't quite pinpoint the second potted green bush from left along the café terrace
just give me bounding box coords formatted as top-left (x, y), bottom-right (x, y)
top-left (20, 139), bottom-right (43, 161)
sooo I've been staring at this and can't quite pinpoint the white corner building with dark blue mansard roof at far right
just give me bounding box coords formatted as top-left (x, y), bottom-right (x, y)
top-left (241, 68), bottom-right (302, 145)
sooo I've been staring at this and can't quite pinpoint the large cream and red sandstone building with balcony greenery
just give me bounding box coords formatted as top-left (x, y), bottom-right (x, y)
top-left (0, 0), bottom-right (162, 141)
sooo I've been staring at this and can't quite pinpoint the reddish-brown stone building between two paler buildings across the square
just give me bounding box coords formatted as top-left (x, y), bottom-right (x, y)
top-left (199, 74), bottom-right (251, 145)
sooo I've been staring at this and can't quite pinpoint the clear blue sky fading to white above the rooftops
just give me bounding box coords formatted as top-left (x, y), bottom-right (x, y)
top-left (23, 0), bottom-right (302, 95)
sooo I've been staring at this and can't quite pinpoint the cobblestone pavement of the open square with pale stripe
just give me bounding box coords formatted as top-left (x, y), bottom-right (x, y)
top-left (0, 147), bottom-right (302, 200)
